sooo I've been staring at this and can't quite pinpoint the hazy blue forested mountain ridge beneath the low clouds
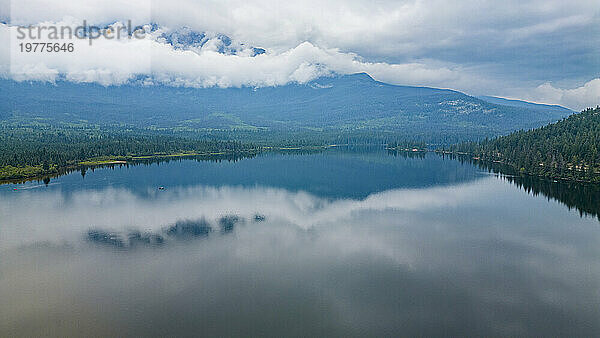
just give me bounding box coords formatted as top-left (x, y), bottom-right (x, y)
top-left (0, 73), bottom-right (572, 142)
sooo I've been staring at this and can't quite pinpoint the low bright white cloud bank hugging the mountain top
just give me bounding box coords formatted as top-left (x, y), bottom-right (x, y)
top-left (0, 20), bottom-right (480, 87)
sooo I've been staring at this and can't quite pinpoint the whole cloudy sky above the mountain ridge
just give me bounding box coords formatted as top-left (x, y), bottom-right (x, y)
top-left (0, 0), bottom-right (600, 110)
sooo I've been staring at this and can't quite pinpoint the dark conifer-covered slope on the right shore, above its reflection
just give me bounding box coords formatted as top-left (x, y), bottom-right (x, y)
top-left (449, 107), bottom-right (600, 183)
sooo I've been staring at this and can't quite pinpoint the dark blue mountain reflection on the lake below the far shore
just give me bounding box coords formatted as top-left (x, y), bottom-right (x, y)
top-left (0, 147), bottom-right (481, 198)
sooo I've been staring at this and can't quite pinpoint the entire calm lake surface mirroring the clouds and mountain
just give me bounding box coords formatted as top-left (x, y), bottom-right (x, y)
top-left (0, 149), bottom-right (600, 336)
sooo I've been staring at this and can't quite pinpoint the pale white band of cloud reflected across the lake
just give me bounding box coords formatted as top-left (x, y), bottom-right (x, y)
top-left (0, 177), bottom-right (488, 248)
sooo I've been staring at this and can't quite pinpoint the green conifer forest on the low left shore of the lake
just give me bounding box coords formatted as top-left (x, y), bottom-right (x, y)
top-left (0, 126), bottom-right (259, 180)
